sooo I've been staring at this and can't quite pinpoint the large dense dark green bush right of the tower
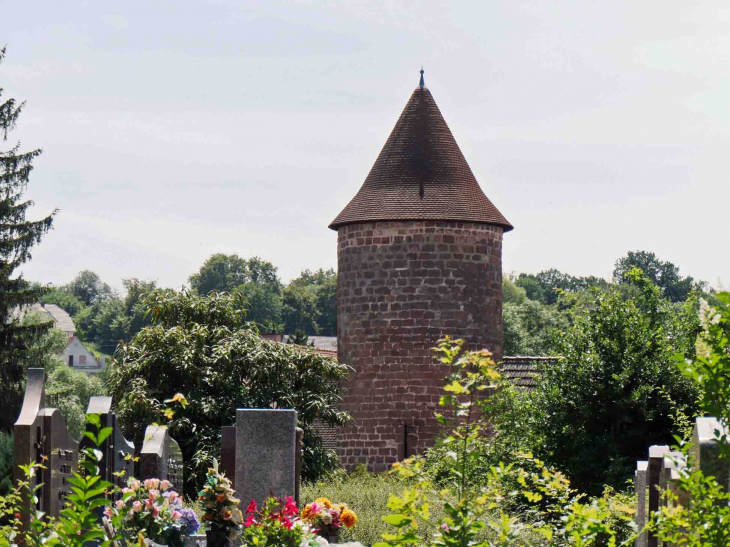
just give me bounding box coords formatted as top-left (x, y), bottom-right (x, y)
top-left (516, 270), bottom-right (699, 495)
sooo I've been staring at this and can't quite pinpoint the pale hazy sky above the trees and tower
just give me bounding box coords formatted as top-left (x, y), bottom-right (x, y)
top-left (0, 0), bottom-right (730, 294)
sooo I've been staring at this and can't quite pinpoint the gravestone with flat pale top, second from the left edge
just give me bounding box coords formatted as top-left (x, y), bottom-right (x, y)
top-left (81, 397), bottom-right (134, 487)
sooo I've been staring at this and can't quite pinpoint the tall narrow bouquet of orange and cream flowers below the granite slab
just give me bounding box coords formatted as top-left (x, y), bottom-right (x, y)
top-left (198, 460), bottom-right (243, 547)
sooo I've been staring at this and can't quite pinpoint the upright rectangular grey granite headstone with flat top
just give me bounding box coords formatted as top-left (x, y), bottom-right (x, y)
top-left (236, 409), bottom-right (297, 505)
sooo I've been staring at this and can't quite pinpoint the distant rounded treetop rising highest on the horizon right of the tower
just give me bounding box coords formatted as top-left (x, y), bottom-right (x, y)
top-left (613, 251), bottom-right (707, 302)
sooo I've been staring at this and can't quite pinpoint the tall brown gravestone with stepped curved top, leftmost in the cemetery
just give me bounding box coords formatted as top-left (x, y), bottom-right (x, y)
top-left (13, 368), bottom-right (79, 525)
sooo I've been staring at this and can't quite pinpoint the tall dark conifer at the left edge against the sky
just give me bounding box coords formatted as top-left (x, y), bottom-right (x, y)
top-left (0, 48), bottom-right (57, 429)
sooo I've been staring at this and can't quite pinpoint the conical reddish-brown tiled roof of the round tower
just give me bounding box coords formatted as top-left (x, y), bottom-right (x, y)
top-left (329, 82), bottom-right (512, 231)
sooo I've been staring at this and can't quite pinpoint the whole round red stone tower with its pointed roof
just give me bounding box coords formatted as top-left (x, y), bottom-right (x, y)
top-left (330, 71), bottom-right (512, 471)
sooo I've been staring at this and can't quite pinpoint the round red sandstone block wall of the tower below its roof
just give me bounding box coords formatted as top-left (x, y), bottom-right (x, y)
top-left (337, 221), bottom-right (502, 471)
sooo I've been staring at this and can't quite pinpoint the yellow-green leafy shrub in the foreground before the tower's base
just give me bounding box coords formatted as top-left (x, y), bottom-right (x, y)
top-left (373, 338), bottom-right (631, 547)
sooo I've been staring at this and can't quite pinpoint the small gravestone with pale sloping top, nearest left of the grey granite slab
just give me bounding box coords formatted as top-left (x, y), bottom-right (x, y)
top-left (139, 425), bottom-right (184, 493)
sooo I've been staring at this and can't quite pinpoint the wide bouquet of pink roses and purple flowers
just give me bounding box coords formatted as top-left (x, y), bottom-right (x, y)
top-left (104, 477), bottom-right (200, 547)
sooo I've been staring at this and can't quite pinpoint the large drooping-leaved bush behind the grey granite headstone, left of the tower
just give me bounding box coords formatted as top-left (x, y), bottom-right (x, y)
top-left (108, 291), bottom-right (348, 492)
